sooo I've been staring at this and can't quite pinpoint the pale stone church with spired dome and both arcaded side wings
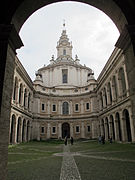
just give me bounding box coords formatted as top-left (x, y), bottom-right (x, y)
top-left (9, 26), bottom-right (135, 143)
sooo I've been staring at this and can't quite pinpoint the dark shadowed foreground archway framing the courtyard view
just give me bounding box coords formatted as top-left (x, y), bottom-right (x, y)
top-left (0, 0), bottom-right (135, 179)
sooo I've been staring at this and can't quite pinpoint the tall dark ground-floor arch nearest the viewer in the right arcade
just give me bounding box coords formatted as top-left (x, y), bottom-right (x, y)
top-left (123, 109), bottom-right (132, 142)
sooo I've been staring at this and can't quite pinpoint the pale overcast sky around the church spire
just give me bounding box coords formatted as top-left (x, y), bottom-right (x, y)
top-left (17, 1), bottom-right (119, 80)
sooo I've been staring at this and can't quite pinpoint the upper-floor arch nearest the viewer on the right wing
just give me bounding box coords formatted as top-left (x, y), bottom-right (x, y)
top-left (118, 67), bottom-right (126, 95)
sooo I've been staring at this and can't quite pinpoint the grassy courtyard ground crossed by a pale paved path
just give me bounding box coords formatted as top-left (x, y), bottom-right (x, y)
top-left (7, 140), bottom-right (135, 180)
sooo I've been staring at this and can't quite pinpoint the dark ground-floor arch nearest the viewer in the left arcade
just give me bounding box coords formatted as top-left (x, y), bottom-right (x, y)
top-left (10, 114), bottom-right (16, 144)
